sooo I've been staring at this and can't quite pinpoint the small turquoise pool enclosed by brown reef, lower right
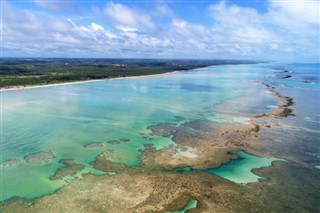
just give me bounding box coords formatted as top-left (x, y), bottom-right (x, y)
top-left (174, 151), bottom-right (285, 184)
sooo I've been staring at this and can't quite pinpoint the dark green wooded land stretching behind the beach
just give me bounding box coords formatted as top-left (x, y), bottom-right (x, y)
top-left (0, 58), bottom-right (253, 88)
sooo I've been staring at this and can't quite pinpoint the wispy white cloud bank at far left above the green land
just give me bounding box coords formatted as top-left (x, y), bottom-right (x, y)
top-left (2, 3), bottom-right (117, 56)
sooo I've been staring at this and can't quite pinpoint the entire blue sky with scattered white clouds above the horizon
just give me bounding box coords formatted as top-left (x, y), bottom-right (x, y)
top-left (0, 0), bottom-right (320, 62)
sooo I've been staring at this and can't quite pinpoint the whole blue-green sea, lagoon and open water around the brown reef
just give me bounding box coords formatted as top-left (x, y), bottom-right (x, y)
top-left (0, 63), bottom-right (320, 205)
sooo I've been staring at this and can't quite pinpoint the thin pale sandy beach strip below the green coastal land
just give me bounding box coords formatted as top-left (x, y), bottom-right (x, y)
top-left (0, 70), bottom-right (180, 92)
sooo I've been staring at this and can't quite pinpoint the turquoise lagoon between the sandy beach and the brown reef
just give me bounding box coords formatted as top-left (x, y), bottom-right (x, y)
top-left (0, 64), bottom-right (314, 200)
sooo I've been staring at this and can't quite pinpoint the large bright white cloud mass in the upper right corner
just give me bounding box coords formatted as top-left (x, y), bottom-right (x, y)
top-left (208, 0), bottom-right (320, 57)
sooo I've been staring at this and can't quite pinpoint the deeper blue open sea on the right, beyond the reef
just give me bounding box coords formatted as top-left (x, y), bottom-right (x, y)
top-left (260, 64), bottom-right (320, 168)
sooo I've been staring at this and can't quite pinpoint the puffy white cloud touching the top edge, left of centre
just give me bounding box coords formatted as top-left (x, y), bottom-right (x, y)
top-left (104, 2), bottom-right (156, 29)
